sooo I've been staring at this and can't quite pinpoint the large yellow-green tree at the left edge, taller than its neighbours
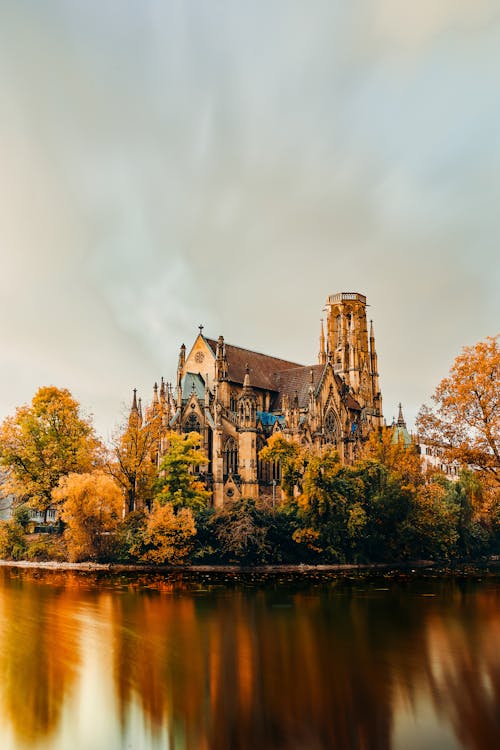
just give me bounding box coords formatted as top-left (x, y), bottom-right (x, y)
top-left (0, 386), bottom-right (102, 518)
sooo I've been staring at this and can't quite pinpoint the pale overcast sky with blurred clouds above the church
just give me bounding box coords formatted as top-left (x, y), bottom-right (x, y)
top-left (0, 0), bottom-right (500, 436)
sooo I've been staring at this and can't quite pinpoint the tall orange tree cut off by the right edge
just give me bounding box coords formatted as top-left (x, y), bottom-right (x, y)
top-left (417, 336), bottom-right (500, 491)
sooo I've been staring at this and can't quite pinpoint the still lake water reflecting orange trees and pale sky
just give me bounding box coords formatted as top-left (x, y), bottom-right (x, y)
top-left (0, 570), bottom-right (500, 750)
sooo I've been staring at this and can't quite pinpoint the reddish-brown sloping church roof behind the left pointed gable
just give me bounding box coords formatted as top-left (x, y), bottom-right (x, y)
top-left (205, 338), bottom-right (301, 391)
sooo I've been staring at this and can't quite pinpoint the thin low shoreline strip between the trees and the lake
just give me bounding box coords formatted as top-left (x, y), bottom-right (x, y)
top-left (0, 556), bottom-right (500, 578)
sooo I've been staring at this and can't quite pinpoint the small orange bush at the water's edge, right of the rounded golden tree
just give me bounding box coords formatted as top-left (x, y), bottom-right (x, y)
top-left (142, 501), bottom-right (196, 565)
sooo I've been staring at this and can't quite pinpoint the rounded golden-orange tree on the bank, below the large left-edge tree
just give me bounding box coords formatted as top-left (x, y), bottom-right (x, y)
top-left (53, 471), bottom-right (123, 561)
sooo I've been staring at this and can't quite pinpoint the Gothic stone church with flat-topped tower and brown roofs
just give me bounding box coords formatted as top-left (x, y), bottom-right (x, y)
top-left (132, 292), bottom-right (383, 507)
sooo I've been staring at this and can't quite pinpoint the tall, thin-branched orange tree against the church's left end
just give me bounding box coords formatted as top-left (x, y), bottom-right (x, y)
top-left (106, 406), bottom-right (161, 513)
